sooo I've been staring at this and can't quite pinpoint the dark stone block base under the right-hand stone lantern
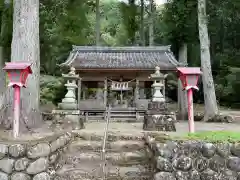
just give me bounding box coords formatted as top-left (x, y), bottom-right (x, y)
top-left (143, 101), bottom-right (176, 131)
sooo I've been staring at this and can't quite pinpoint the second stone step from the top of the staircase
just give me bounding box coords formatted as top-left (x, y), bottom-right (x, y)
top-left (68, 138), bottom-right (145, 152)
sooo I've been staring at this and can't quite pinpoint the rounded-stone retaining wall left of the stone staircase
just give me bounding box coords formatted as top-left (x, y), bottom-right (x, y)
top-left (0, 133), bottom-right (72, 180)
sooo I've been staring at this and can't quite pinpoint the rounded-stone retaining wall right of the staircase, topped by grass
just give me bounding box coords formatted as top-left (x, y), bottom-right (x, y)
top-left (145, 135), bottom-right (240, 180)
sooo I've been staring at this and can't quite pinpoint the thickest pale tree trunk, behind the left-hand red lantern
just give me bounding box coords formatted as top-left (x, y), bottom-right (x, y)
top-left (6, 0), bottom-right (42, 128)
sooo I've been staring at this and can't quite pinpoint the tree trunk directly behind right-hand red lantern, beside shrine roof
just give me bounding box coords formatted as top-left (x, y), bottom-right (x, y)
top-left (178, 43), bottom-right (188, 120)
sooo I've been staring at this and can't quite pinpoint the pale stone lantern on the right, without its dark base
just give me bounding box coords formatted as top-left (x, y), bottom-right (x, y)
top-left (149, 66), bottom-right (167, 102)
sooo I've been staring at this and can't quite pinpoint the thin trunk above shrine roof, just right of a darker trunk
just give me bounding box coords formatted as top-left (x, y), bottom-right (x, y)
top-left (149, 0), bottom-right (154, 46)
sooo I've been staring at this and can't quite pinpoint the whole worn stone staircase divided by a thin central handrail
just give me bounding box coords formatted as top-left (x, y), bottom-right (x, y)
top-left (55, 131), bottom-right (153, 180)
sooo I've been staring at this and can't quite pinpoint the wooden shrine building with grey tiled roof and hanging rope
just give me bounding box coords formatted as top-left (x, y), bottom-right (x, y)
top-left (61, 46), bottom-right (185, 119)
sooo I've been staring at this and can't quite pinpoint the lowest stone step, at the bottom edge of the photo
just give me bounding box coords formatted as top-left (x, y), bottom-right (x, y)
top-left (54, 163), bottom-right (152, 180)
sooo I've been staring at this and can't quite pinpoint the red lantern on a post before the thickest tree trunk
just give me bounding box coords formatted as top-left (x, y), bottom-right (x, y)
top-left (3, 62), bottom-right (32, 138)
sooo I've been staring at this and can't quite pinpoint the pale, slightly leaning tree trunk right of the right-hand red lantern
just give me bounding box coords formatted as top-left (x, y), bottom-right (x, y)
top-left (198, 0), bottom-right (218, 121)
